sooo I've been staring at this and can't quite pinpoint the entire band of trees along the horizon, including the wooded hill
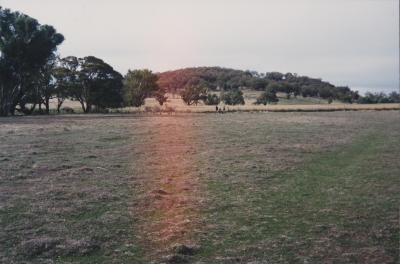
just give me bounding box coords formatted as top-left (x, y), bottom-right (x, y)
top-left (0, 7), bottom-right (399, 116)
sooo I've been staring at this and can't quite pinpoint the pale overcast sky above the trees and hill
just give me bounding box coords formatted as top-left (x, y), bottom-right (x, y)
top-left (0, 0), bottom-right (399, 93)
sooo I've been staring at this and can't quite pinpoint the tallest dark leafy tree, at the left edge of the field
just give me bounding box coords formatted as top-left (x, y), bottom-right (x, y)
top-left (0, 7), bottom-right (64, 115)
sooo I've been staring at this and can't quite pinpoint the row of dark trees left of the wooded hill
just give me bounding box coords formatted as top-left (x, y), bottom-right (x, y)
top-left (0, 7), bottom-right (166, 116)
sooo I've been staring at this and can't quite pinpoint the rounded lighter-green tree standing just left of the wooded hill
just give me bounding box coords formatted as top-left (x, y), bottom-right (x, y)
top-left (123, 69), bottom-right (159, 107)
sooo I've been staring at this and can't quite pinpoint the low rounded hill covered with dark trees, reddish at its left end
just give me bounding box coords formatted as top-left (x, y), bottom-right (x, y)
top-left (158, 67), bottom-right (359, 102)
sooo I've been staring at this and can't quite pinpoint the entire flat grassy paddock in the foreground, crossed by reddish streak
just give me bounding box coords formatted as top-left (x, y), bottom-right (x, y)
top-left (0, 111), bottom-right (400, 263)
